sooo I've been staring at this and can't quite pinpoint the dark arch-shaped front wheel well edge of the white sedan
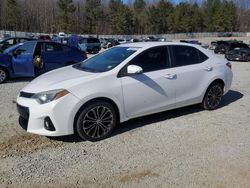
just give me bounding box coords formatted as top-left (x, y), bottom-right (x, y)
top-left (73, 97), bottom-right (120, 133)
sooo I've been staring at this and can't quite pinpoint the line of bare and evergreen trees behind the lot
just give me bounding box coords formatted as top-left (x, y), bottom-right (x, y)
top-left (0, 0), bottom-right (250, 34)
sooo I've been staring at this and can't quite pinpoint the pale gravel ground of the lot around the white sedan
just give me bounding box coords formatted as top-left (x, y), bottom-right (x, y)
top-left (0, 43), bottom-right (250, 188)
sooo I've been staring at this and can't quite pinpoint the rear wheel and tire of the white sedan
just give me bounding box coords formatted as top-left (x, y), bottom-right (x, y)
top-left (201, 82), bottom-right (223, 110)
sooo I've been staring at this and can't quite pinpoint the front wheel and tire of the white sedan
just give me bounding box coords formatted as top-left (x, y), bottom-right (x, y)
top-left (76, 101), bottom-right (117, 142)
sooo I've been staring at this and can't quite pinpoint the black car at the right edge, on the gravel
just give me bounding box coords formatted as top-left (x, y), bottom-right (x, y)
top-left (225, 43), bottom-right (250, 61)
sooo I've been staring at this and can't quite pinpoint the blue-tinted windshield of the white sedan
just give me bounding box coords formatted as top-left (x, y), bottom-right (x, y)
top-left (73, 47), bottom-right (139, 72)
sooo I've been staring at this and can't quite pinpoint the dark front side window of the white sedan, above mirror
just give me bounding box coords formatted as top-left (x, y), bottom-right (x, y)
top-left (129, 46), bottom-right (169, 72)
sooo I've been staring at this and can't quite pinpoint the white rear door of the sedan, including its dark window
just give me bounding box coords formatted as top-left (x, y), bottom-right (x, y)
top-left (170, 45), bottom-right (213, 107)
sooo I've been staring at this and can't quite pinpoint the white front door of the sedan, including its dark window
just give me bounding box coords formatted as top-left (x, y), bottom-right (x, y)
top-left (121, 46), bottom-right (176, 118)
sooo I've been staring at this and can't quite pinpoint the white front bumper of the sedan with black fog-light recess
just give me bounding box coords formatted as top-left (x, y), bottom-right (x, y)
top-left (17, 93), bottom-right (82, 136)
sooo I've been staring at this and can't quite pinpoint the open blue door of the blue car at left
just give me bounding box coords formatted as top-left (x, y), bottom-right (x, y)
top-left (12, 42), bottom-right (37, 77)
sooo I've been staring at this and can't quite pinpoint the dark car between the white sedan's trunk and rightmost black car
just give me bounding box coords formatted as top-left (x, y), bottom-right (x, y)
top-left (214, 40), bottom-right (246, 54)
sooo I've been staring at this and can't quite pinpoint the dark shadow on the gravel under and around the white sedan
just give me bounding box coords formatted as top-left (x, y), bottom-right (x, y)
top-left (50, 90), bottom-right (244, 142)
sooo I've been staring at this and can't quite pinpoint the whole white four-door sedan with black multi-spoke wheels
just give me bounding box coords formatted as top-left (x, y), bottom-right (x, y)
top-left (17, 42), bottom-right (233, 141)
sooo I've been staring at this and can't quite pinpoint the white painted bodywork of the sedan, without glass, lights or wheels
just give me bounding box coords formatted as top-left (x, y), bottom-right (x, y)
top-left (17, 42), bottom-right (232, 136)
